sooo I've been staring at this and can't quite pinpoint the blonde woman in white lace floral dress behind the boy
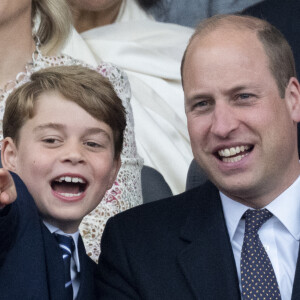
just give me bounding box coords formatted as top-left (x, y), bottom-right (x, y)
top-left (0, 0), bottom-right (143, 261)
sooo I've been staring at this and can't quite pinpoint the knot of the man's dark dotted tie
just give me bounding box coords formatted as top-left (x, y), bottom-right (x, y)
top-left (244, 208), bottom-right (273, 233)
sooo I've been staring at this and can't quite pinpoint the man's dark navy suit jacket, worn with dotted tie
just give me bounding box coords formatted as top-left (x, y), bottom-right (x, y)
top-left (96, 182), bottom-right (300, 300)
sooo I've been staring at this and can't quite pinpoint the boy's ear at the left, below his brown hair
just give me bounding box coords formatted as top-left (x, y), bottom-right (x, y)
top-left (1, 137), bottom-right (18, 172)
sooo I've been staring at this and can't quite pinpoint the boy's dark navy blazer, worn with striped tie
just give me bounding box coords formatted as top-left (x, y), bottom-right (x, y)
top-left (0, 174), bottom-right (96, 300)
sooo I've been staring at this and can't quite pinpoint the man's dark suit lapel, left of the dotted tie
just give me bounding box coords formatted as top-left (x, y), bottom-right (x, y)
top-left (178, 183), bottom-right (241, 300)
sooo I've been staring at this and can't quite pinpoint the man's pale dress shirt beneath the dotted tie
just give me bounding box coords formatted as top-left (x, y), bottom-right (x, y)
top-left (220, 177), bottom-right (300, 300)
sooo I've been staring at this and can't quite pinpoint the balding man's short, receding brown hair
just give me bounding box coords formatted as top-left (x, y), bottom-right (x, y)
top-left (181, 15), bottom-right (297, 98)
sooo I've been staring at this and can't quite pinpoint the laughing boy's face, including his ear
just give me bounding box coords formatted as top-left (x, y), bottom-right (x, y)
top-left (2, 92), bottom-right (120, 233)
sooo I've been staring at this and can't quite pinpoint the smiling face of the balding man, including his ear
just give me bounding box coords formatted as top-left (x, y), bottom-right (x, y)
top-left (183, 28), bottom-right (300, 204)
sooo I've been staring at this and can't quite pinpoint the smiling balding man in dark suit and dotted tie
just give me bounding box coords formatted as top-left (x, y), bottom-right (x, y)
top-left (98, 15), bottom-right (300, 299)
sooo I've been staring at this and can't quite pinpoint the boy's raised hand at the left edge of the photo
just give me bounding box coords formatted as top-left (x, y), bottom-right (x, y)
top-left (0, 168), bottom-right (17, 208)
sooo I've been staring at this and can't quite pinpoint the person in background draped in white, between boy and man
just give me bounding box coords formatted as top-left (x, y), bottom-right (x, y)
top-left (63, 0), bottom-right (192, 194)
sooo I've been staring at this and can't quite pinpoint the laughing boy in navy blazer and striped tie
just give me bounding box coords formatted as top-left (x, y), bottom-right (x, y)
top-left (0, 66), bottom-right (126, 300)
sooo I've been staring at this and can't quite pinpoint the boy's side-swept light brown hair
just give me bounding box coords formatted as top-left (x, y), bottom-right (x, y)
top-left (3, 65), bottom-right (126, 157)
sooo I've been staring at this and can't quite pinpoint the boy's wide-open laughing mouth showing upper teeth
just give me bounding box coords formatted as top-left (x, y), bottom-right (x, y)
top-left (51, 176), bottom-right (88, 197)
